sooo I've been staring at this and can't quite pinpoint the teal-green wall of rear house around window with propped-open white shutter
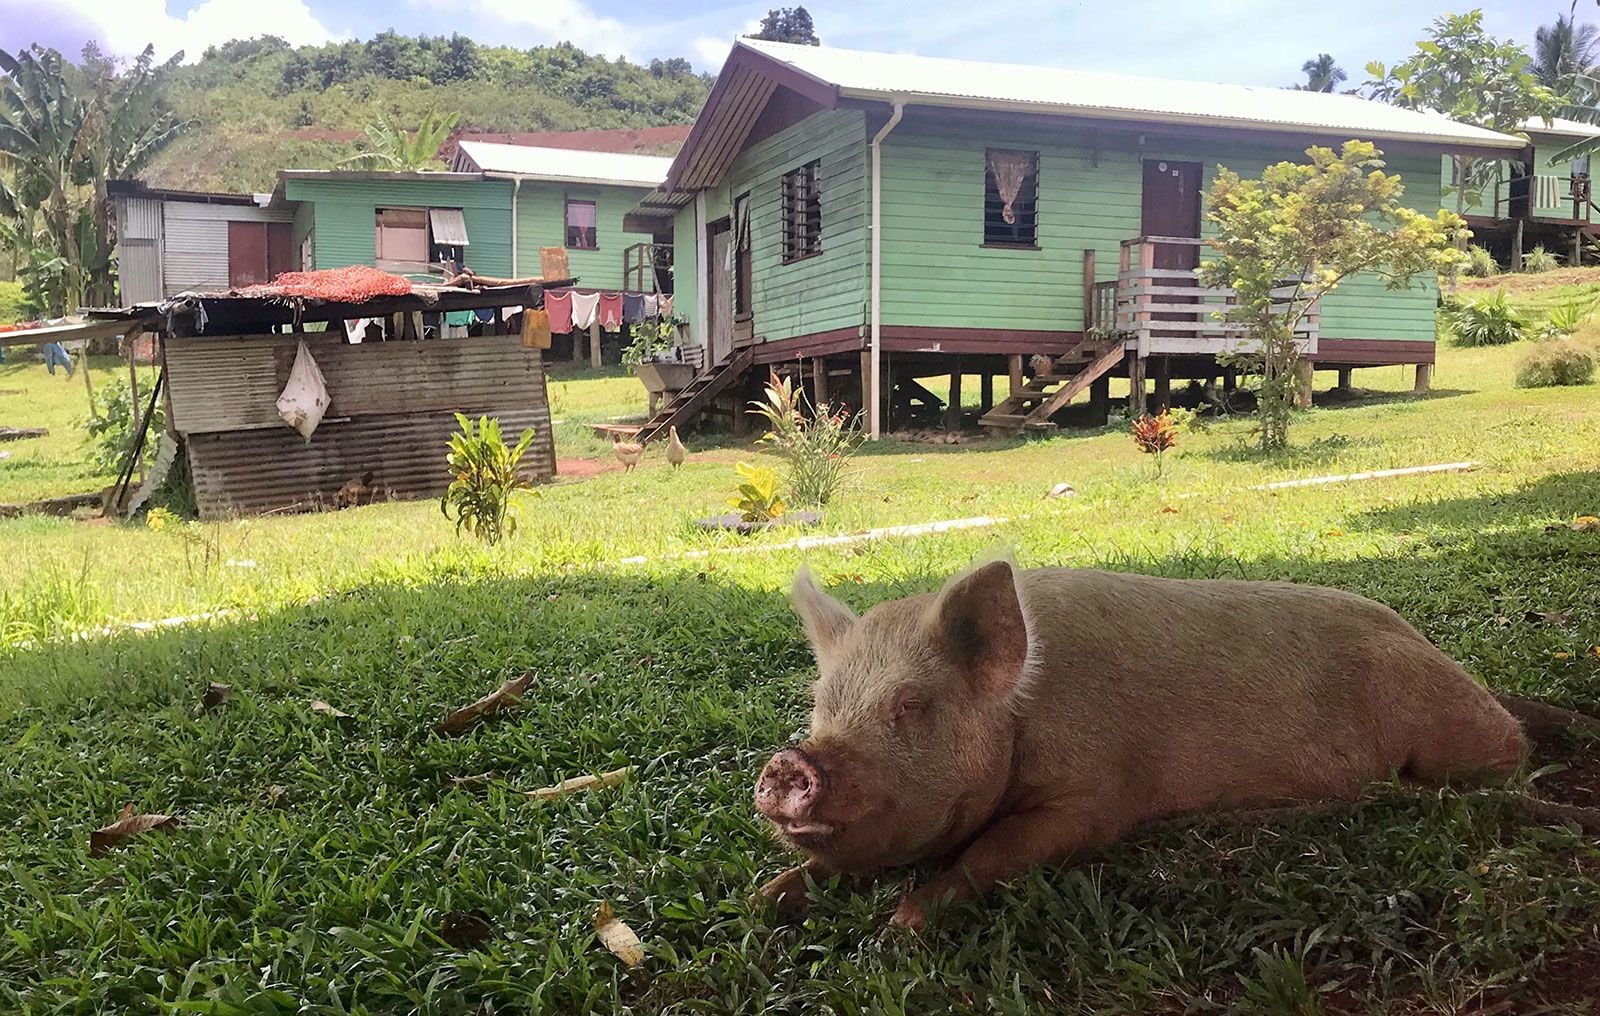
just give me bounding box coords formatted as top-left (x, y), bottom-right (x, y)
top-left (285, 178), bottom-right (512, 275)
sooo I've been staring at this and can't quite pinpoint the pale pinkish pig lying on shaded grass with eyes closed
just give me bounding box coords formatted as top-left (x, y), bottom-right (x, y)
top-left (755, 560), bottom-right (1528, 930)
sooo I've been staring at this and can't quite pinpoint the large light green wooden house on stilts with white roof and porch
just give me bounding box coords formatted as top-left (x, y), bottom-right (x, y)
top-left (645, 40), bottom-right (1526, 440)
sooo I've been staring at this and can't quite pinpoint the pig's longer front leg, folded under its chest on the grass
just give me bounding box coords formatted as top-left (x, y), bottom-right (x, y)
top-left (893, 806), bottom-right (1125, 931)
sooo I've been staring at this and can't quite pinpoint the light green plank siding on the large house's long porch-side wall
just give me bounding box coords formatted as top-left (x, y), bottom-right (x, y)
top-left (882, 118), bottom-right (1438, 339)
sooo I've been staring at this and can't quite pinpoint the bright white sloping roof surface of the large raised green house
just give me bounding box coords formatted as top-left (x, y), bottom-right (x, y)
top-left (738, 38), bottom-right (1526, 149)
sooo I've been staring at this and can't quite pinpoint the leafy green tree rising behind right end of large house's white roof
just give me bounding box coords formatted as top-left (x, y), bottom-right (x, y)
top-left (1366, 11), bottom-right (1555, 232)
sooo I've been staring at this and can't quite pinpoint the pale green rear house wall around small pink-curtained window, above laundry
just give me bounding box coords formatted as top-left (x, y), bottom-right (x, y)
top-left (507, 181), bottom-right (651, 290)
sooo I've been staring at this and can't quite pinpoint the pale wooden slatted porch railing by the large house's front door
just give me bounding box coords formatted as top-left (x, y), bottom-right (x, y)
top-left (1094, 237), bottom-right (1320, 357)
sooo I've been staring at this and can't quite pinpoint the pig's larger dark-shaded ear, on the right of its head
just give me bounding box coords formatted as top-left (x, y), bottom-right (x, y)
top-left (930, 560), bottom-right (1029, 698)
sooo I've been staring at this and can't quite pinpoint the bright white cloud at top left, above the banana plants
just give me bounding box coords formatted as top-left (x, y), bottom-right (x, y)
top-left (58, 0), bottom-right (340, 62)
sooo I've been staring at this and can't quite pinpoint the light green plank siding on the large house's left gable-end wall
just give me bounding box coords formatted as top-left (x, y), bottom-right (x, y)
top-left (723, 110), bottom-right (869, 341)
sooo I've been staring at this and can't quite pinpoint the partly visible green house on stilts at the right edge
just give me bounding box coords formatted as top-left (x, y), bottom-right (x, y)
top-left (1440, 117), bottom-right (1600, 269)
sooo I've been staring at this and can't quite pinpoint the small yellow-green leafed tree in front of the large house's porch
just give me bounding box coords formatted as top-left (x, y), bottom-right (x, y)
top-left (1200, 141), bottom-right (1466, 453)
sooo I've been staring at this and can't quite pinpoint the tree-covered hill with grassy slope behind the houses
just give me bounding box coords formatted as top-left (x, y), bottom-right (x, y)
top-left (141, 32), bottom-right (710, 190)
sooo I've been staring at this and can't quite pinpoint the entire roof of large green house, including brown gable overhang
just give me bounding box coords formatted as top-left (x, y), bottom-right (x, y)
top-left (669, 38), bottom-right (1526, 189)
